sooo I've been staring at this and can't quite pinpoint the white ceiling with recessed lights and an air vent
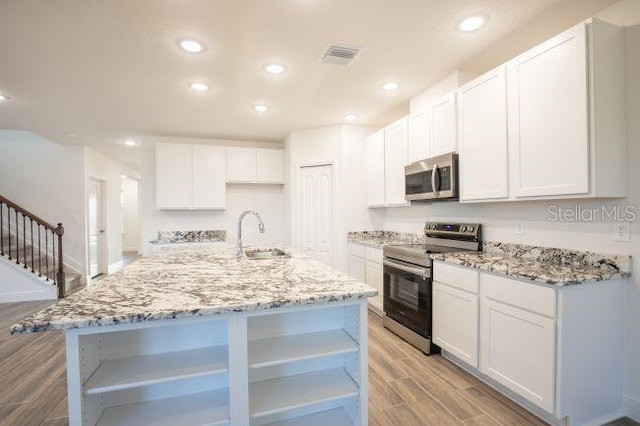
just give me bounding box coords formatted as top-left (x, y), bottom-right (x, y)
top-left (0, 0), bottom-right (614, 166)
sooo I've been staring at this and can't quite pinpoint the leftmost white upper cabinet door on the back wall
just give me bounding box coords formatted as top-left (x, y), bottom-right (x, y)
top-left (156, 144), bottom-right (192, 210)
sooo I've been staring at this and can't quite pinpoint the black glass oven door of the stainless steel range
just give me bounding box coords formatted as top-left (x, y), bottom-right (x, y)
top-left (383, 258), bottom-right (431, 337)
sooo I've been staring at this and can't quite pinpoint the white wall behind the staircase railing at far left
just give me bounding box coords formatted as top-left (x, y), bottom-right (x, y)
top-left (0, 130), bottom-right (85, 272)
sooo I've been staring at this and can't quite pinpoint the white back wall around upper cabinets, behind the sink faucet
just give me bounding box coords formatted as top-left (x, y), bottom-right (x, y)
top-left (140, 136), bottom-right (287, 255)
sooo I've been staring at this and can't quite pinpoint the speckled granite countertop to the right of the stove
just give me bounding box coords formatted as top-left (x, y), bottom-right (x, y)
top-left (431, 242), bottom-right (631, 287)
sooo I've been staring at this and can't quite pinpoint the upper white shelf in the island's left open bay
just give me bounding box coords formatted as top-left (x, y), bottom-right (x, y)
top-left (85, 345), bottom-right (229, 395)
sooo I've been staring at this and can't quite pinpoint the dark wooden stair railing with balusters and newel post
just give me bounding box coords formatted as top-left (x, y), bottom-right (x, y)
top-left (0, 195), bottom-right (66, 298)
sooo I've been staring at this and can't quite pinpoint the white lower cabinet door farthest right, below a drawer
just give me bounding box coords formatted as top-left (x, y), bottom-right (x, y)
top-left (480, 299), bottom-right (555, 413)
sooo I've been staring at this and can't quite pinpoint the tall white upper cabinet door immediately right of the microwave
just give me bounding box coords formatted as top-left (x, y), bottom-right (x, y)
top-left (458, 67), bottom-right (509, 201)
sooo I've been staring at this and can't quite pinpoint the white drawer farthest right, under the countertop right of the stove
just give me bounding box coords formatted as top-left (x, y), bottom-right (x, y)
top-left (480, 274), bottom-right (556, 317)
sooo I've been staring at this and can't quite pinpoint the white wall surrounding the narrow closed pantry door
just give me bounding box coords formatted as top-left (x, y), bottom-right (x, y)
top-left (286, 125), bottom-right (374, 272)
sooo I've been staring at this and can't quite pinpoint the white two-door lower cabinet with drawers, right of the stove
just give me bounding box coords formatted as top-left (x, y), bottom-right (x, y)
top-left (433, 261), bottom-right (625, 425)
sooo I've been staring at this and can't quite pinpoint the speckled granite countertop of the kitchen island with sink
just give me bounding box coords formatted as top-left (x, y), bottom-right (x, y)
top-left (11, 244), bottom-right (377, 334)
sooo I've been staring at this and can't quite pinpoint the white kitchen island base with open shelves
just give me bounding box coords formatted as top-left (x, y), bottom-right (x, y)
top-left (65, 298), bottom-right (367, 426)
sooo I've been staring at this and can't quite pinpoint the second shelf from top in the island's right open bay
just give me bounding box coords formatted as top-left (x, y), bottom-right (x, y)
top-left (249, 368), bottom-right (358, 418)
